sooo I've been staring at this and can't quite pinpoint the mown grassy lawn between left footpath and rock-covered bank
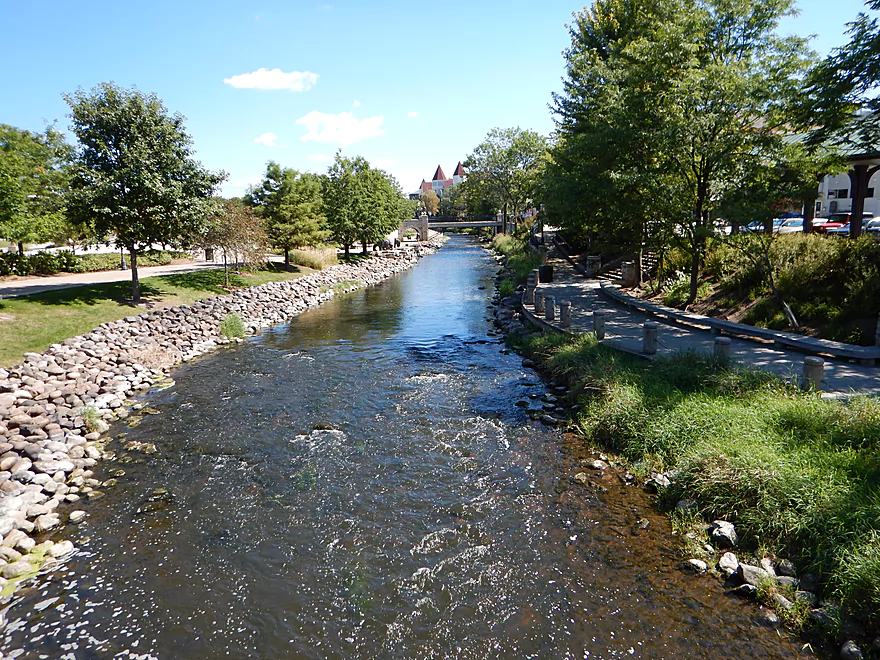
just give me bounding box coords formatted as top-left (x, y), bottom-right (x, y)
top-left (0, 268), bottom-right (314, 367)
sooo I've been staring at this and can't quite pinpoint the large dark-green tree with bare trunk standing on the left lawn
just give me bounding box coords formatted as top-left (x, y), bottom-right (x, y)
top-left (64, 83), bottom-right (226, 304)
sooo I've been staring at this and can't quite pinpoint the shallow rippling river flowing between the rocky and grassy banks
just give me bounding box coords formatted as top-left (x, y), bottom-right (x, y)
top-left (0, 238), bottom-right (803, 659)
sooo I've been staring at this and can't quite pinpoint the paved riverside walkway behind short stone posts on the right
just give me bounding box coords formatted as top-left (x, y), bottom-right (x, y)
top-left (528, 250), bottom-right (880, 396)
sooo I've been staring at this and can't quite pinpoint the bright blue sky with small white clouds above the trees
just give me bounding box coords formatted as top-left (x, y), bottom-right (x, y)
top-left (0, 0), bottom-right (864, 195)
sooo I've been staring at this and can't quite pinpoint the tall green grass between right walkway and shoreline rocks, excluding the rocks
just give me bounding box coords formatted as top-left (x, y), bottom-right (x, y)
top-left (522, 336), bottom-right (880, 625)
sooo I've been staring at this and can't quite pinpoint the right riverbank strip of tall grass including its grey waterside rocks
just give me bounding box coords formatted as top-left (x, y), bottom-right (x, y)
top-left (496, 260), bottom-right (880, 658)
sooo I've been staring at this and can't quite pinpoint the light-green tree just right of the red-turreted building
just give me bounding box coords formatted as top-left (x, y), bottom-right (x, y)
top-left (464, 127), bottom-right (547, 231)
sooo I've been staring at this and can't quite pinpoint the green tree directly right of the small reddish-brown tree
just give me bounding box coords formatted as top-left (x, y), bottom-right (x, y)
top-left (247, 161), bottom-right (327, 268)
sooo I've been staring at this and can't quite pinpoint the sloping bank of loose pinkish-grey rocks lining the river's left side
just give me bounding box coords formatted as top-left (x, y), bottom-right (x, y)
top-left (0, 242), bottom-right (439, 596)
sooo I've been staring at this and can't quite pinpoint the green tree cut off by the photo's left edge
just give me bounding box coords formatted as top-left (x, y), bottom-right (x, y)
top-left (0, 124), bottom-right (71, 253)
